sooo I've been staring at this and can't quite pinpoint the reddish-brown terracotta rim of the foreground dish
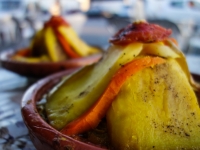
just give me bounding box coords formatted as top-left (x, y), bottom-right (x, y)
top-left (22, 69), bottom-right (200, 150)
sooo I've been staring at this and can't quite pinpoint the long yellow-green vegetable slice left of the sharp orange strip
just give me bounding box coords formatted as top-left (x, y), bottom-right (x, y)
top-left (46, 43), bottom-right (142, 129)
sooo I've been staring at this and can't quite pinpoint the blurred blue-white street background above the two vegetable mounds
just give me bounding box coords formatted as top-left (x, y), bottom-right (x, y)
top-left (0, 0), bottom-right (200, 55)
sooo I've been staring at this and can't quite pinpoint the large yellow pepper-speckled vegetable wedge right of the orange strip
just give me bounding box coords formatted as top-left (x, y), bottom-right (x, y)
top-left (107, 59), bottom-right (200, 150)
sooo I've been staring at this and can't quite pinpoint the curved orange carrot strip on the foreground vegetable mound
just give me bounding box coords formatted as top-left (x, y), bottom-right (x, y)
top-left (61, 56), bottom-right (165, 135)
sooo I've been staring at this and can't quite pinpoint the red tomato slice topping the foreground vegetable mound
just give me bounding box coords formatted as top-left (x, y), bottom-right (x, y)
top-left (110, 21), bottom-right (172, 45)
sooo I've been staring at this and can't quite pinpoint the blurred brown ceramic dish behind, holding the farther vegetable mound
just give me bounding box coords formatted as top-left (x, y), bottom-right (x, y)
top-left (0, 49), bottom-right (102, 78)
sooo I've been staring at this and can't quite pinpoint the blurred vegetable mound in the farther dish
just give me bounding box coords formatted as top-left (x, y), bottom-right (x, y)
top-left (12, 16), bottom-right (101, 63)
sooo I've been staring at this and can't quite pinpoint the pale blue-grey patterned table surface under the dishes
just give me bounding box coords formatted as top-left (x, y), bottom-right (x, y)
top-left (0, 56), bottom-right (200, 150)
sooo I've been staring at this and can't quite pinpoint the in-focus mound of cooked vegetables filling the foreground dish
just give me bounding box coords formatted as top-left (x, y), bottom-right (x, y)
top-left (26, 21), bottom-right (200, 150)
